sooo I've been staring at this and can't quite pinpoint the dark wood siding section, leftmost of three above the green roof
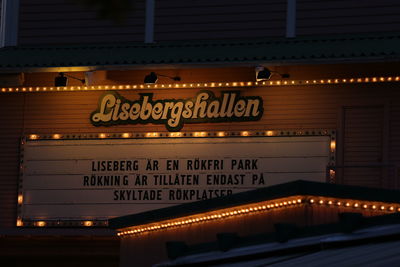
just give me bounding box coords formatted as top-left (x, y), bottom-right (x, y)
top-left (18, 0), bottom-right (145, 45)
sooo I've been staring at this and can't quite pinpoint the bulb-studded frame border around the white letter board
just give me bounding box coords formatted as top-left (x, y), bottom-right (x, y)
top-left (16, 129), bottom-right (336, 227)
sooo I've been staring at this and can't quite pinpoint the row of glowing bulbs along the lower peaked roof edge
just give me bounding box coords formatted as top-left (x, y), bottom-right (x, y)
top-left (117, 197), bottom-right (400, 237)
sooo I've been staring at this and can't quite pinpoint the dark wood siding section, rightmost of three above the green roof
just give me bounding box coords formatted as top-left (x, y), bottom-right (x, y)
top-left (296, 0), bottom-right (400, 35)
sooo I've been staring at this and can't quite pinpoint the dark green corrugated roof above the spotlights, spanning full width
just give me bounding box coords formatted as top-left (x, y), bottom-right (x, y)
top-left (0, 33), bottom-right (400, 72)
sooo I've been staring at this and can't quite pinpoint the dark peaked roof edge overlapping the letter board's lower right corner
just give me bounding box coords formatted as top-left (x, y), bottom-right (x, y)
top-left (109, 180), bottom-right (400, 229)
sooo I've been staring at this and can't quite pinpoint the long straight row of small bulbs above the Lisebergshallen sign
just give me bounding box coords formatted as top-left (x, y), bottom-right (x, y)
top-left (1, 76), bottom-right (400, 93)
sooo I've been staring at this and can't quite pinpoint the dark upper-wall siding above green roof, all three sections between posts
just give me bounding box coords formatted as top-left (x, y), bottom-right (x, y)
top-left (19, 0), bottom-right (400, 45)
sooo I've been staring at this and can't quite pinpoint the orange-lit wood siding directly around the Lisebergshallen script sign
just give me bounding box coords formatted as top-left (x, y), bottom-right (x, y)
top-left (11, 84), bottom-right (398, 146)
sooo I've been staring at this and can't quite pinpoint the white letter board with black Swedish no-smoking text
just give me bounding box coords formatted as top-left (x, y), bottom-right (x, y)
top-left (20, 136), bottom-right (330, 221)
